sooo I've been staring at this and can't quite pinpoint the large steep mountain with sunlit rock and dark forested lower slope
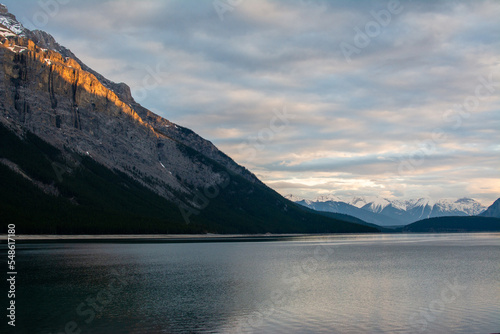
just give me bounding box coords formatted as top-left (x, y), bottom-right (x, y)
top-left (0, 5), bottom-right (378, 234)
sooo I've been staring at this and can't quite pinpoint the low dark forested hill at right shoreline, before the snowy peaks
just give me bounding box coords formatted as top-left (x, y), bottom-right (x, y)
top-left (401, 216), bottom-right (500, 233)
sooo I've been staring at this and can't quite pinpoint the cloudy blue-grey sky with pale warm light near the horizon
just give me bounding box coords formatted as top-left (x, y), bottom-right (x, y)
top-left (2, 0), bottom-right (500, 205)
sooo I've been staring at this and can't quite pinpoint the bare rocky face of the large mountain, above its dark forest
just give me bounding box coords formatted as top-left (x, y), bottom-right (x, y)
top-left (0, 10), bottom-right (260, 206)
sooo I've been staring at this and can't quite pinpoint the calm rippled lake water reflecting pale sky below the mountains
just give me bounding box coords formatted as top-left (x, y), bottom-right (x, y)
top-left (1, 234), bottom-right (500, 334)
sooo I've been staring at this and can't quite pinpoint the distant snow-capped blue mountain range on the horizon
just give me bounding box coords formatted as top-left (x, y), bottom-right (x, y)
top-left (285, 195), bottom-right (486, 226)
